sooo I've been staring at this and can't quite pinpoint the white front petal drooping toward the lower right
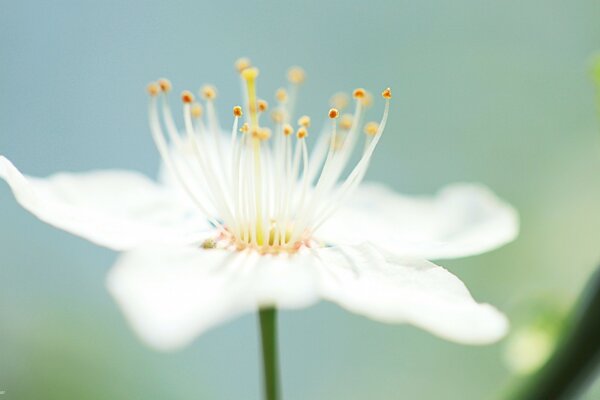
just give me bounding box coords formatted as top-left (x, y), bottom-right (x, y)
top-left (318, 244), bottom-right (508, 344)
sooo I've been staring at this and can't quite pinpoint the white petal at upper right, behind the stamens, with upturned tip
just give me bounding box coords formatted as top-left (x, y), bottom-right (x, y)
top-left (316, 183), bottom-right (519, 259)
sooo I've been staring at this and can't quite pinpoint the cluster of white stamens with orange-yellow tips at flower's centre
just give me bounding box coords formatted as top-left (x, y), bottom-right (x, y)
top-left (148, 58), bottom-right (392, 253)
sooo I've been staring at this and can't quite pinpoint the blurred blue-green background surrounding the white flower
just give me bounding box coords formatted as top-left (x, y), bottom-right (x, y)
top-left (0, 0), bottom-right (600, 400)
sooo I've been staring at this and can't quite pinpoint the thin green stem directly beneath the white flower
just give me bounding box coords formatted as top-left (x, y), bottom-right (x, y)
top-left (259, 308), bottom-right (280, 400)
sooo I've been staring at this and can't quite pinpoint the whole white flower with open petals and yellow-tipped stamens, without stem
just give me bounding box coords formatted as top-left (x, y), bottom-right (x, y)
top-left (0, 60), bottom-right (518, 349)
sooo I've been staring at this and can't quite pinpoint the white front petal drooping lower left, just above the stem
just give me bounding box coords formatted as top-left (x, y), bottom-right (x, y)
top-left (108, 247), bottom-right (318, 350)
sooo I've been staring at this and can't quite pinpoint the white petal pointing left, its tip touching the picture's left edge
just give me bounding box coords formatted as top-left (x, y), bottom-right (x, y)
top-left (0, 156), bottom-right (209, 250)
